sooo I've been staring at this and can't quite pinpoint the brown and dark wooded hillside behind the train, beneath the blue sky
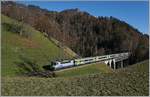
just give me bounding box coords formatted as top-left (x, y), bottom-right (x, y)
top-left (2, 1), bottom-right (149, 63)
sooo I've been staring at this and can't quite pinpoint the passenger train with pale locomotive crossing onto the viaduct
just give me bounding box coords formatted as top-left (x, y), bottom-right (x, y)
top-left (52, 53), bottom-right (128, 70)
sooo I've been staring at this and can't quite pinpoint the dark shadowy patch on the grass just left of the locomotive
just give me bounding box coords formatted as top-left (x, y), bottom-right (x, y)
top-left (15, 57), bottom-right (55, 78)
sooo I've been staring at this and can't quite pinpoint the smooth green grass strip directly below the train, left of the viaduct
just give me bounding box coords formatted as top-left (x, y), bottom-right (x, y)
top-left (55, 63), bottom-right (112, 77)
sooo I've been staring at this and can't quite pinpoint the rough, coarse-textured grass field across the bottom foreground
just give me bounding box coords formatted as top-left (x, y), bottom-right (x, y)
top-left (1, 60), bottom-right (149, 96)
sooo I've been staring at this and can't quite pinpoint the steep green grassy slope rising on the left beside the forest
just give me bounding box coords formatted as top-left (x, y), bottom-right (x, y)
top-left (1, 15), bottom-right (72, 76)
